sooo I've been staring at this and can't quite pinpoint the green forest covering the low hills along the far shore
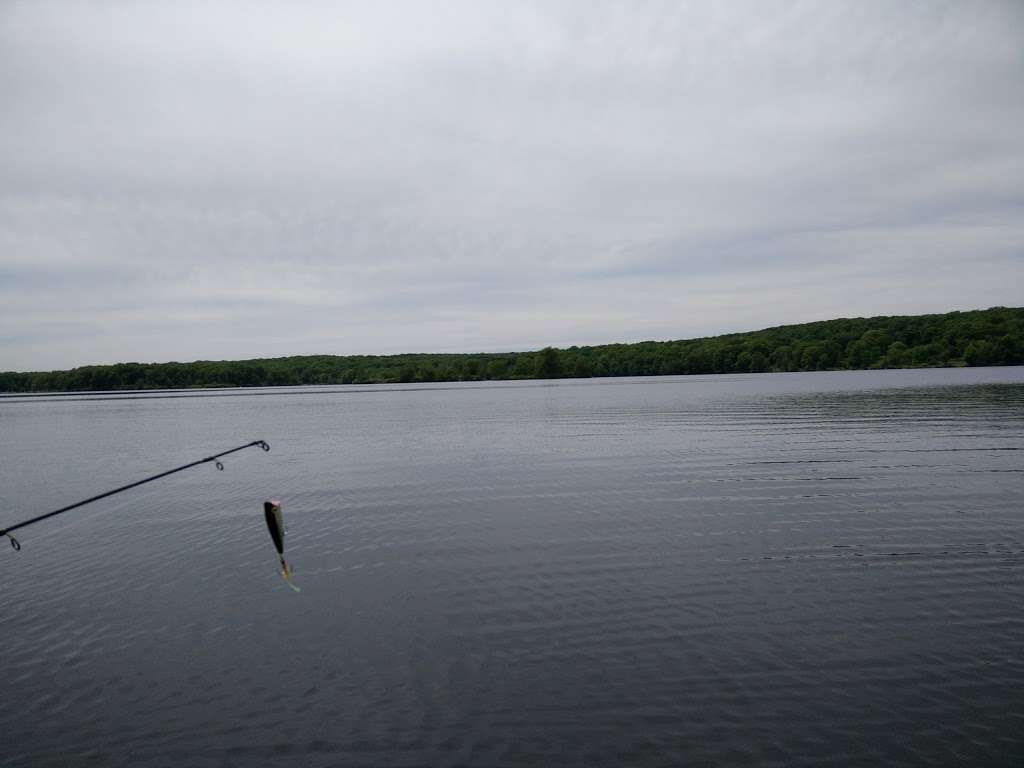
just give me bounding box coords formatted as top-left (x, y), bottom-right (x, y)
top-left (0, 307), bottom-right (1024, 392)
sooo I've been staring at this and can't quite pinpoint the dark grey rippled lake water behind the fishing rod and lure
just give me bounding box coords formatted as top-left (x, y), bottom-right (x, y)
top-left (0, 369), bottom-right (1024, 766)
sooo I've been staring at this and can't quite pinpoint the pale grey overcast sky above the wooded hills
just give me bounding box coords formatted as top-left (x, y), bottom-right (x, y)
top-left (0, 0), bottom-right (1024, 371)
